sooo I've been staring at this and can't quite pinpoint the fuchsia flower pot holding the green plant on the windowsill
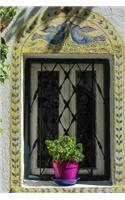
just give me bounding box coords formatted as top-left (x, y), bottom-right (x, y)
top-left (52, 161), bottom-right (79, 180)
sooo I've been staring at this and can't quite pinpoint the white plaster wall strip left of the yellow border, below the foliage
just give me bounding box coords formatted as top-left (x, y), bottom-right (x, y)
top-left (0, 81), bottom-right (11, 192)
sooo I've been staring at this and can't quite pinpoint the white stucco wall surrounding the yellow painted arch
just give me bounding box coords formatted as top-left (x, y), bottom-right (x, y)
top-left (0, 7), bottom-right (125, 192)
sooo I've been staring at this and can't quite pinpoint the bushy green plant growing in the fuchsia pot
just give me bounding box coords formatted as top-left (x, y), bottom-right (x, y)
top-left (45, 135), bottom-right (84, 162)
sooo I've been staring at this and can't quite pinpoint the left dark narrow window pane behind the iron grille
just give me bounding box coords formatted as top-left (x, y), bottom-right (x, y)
top-left (37, 71), bottom-right (59, 167)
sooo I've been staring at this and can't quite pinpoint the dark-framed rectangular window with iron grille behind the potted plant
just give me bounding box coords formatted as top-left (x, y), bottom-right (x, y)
top-left (24, 58), bottom-right (110, 181)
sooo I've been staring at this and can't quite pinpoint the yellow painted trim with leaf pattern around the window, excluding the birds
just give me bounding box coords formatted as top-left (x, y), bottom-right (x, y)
top-left (10, 9), bottom-right (125, 192)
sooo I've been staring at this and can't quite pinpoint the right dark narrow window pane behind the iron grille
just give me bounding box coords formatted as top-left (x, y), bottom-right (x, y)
top-left (76, 71), bottom-right (96, 168)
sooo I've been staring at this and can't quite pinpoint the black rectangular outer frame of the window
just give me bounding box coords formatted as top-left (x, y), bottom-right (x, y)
top-left (24, 58), bottom-right (111, 181)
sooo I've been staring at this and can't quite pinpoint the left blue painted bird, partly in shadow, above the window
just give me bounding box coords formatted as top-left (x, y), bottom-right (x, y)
top-left (42, 24), bottom-right (65, 45)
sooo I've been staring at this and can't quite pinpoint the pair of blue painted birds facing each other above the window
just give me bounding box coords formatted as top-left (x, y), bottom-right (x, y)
top-left (31, 21), bottom-right (105, 45)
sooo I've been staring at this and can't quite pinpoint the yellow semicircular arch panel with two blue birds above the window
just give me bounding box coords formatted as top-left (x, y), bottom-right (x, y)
top-left (15, 9), bottom-right (123, 54)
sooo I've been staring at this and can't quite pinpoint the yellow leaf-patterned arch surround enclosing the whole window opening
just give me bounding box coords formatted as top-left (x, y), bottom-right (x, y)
top-left (10, 9), bottom-right (125, 192)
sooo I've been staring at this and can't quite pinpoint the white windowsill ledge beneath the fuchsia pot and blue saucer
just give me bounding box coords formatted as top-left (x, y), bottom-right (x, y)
top-left (23, 180), bottom-right (112, 188)
